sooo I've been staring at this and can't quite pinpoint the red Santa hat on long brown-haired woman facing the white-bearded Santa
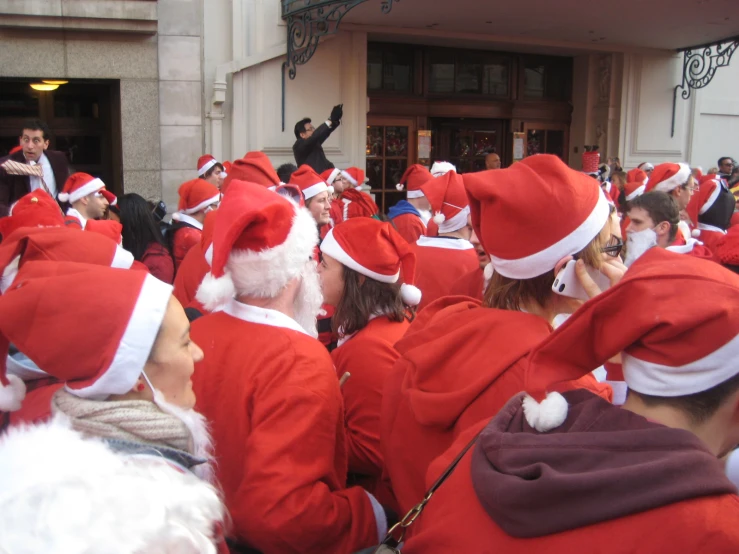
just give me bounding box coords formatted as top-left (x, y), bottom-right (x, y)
top-left (321, 217), bottom-right (421, 306)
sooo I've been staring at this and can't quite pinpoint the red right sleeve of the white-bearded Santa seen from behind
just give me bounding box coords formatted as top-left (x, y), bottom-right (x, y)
top-left (230, 343), bottom-right (378, 554)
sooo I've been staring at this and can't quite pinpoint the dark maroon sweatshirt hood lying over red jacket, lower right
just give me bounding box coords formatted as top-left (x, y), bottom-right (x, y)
top-left (471, 390), bottom-right (736, 538)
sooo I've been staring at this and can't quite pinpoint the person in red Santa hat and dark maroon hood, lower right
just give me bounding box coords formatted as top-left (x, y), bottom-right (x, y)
top-left (403, 248), bottom-right (739, 554)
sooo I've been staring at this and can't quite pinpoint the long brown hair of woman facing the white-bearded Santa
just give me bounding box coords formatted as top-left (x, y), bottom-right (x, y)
top-left (331, 266), bottom-right (416, 336)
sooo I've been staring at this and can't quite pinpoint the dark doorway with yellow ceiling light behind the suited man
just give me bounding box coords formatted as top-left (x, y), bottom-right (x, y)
top-left (0, 79), bottom-right (123, 194)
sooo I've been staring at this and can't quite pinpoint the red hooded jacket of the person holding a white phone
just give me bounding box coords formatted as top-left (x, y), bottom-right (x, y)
top-left (380, 297), bottom-right (611, 513)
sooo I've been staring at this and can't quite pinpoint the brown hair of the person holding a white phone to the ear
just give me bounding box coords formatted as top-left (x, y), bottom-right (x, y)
top-left (483, 222), bottom-right (611, 310)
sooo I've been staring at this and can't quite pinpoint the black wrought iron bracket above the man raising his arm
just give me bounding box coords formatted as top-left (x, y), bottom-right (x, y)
top-left (282, 0), bottom-right (400, 131)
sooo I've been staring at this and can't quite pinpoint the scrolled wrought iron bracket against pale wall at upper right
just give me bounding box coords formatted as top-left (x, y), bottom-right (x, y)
top-left (670, 37), bottom-right (739, 137)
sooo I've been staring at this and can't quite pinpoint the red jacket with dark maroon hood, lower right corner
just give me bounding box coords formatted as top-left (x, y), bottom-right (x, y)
top-left (403, 391), bottom-right (739, 554)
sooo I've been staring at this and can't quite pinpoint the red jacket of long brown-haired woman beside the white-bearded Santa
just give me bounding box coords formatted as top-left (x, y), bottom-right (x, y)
top-left (331, 316), bottom-right (409, 492)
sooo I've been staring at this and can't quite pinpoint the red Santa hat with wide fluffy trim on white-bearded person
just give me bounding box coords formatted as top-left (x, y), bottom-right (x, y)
top-left (195, 181), bottom-right (318, 311)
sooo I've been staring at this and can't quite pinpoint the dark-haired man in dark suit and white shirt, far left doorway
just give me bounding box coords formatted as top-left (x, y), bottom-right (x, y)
top-left (0, 119), bottom-right (69, 206)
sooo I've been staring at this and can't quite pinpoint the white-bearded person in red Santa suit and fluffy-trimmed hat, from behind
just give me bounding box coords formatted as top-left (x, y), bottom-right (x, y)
top-left (192, 180), bottom-right (387, 554)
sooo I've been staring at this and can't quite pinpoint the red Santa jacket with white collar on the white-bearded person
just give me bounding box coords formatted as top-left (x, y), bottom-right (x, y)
top-left (191, 300), bottom-right (382, 554)
